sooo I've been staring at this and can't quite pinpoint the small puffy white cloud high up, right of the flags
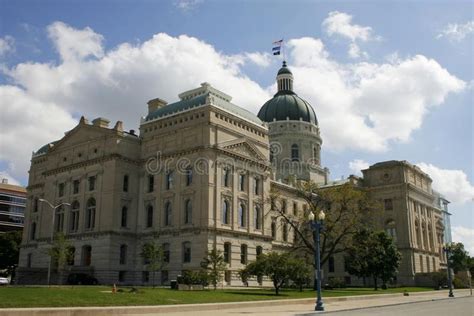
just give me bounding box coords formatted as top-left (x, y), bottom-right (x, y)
top-left (322, 11), bottom-right (379, 59)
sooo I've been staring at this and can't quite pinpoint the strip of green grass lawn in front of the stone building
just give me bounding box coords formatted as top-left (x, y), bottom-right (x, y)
top-left (0, 286), bottom-right (432, 308)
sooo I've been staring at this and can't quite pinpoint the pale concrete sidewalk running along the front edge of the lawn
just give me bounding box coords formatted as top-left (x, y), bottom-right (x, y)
top-left (0, 290), bottom-right (474, 316)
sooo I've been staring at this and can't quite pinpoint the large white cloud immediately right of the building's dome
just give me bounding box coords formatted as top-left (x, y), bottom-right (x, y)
top-left (288, 37), bottom-right (466, 152)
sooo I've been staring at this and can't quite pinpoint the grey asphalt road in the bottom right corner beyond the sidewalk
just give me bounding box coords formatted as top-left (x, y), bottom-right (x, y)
top-left (310, 296), bottom-right (474, 316)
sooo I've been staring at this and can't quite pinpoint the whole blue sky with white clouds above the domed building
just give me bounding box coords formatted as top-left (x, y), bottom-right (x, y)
top-left (0, 0), bottom-right (474, 255)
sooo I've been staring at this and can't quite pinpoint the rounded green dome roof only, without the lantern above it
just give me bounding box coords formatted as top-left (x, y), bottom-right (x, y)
top-left (258, 90), bottom-right (318, 125)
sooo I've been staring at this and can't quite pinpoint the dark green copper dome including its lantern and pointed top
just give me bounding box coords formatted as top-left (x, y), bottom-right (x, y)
top-left (258, 62), bottom-right (318, 125)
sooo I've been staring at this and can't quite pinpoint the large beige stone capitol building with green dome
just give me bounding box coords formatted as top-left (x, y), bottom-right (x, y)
top-left (18, 62), bottom-right (450, 285)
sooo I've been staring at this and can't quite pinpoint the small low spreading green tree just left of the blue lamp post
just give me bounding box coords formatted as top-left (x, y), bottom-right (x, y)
top-left (240, 252), bottom-right (292, 295)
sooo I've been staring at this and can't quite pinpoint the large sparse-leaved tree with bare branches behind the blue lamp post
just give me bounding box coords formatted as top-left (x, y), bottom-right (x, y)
top-left (270, 182), bottom-right (380, 265)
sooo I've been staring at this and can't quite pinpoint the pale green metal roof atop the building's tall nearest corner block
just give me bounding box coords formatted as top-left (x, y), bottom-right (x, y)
top-left (143, 83), bottom-right (263, 125)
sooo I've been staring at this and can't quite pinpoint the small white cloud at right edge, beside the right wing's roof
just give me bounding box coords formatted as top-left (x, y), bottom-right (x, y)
top-left (417, 162), bottom-right (474, 205)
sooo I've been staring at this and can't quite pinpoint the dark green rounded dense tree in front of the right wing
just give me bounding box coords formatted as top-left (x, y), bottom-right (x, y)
top-left (346, 229), bottom-right (401, 290)
